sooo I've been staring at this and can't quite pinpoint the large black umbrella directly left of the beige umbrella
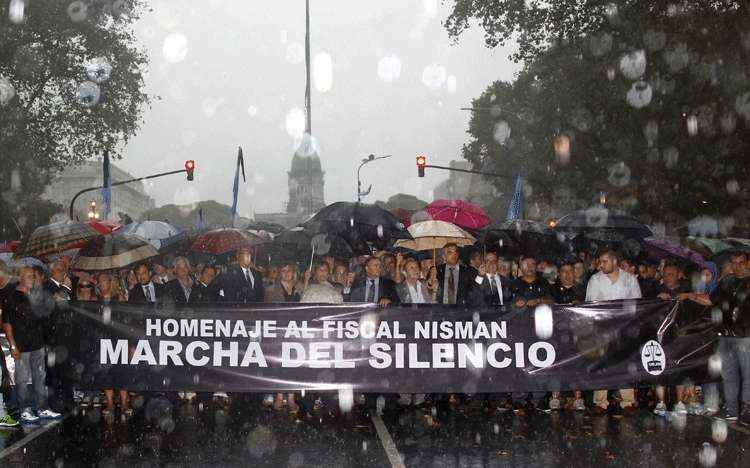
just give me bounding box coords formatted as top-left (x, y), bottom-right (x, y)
top-left (303, 202), bottom-right (411, 252)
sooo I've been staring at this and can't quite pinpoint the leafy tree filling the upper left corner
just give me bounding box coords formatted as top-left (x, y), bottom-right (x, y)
top-left (0, 0), bottom-right (150, 239)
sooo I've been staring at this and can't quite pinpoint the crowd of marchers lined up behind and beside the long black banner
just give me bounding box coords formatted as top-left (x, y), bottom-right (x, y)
top-left (0, 244), bottom-right (750, 427)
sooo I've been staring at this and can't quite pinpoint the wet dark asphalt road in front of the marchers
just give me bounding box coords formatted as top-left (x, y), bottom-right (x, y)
top-left (0, 400), bottom-right (750, 468)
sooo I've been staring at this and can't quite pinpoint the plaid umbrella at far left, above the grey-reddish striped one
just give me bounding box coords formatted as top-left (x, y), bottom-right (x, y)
top-left (16, 221), bottom-right (119, 258)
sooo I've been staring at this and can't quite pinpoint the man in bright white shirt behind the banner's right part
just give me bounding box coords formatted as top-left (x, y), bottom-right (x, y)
top-left (586, 248), bottom-right (641, 414)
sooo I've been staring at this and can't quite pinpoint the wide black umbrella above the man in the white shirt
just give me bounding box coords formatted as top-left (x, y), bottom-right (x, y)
top-left (555, 207), bottom-right (653, 242)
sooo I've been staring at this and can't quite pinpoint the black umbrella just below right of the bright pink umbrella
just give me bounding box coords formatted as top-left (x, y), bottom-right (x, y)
top-left (478, 219), bottom-right (561, 256)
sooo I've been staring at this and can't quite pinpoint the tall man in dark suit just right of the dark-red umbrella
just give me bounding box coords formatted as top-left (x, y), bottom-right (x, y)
top-left (212, 247), bottom-right (265, 303)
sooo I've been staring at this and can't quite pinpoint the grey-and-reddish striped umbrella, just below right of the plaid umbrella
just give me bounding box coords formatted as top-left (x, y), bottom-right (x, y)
top-left (73, 233), bottom-right (159, 271)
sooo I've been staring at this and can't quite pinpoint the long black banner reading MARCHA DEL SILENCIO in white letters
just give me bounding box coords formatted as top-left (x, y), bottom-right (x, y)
top-left (55, 301), bottom-right (717, 393)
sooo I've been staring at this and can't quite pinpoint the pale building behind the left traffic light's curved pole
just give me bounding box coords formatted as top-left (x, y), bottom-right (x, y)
top-left (43, 161), bottom-right (156, 220)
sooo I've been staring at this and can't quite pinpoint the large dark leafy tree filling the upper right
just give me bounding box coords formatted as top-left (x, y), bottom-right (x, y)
top-left (448, 1), bottom-right (750, 229)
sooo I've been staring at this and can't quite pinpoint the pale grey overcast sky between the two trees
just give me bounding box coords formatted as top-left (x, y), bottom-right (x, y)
top-left (119, 0), bottom-right (518, 216)
